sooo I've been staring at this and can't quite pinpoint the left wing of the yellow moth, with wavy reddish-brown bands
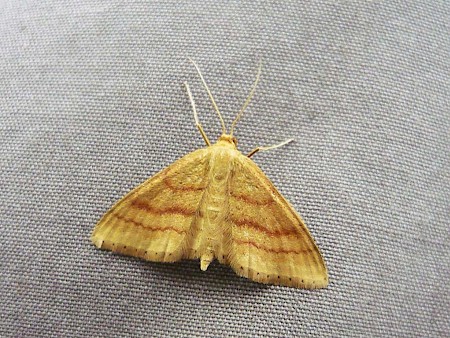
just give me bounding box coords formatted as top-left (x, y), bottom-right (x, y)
top-left (91, 148), bottom-right (209, 262)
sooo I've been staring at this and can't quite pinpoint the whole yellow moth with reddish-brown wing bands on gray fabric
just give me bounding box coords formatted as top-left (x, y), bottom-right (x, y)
top-left (91, 60), bottom-right (328, 289)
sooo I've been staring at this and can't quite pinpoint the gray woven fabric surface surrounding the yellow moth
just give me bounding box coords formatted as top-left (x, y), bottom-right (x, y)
top-left (0, 0), bottom-right (450, 337)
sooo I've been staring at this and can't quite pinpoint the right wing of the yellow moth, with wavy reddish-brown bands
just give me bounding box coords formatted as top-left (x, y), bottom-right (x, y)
top-left (227, 155), bottom-right (328, 289)
